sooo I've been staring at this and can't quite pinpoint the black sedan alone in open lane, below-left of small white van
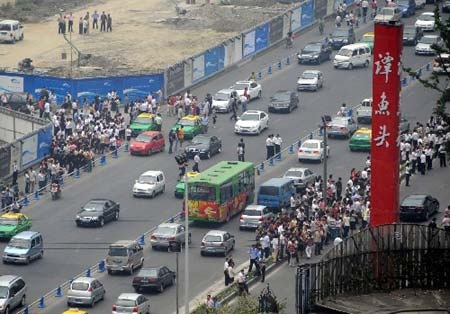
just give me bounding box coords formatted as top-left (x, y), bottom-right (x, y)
top-left (75, 199), bottom-right (120, 227)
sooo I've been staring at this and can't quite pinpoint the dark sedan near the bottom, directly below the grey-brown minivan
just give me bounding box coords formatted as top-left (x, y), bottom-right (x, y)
top-left (133, 266), bottom-right (176, 293)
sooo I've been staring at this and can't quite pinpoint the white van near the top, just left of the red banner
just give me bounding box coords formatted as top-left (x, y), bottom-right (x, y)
top-left (333, 43), bottom-right (372, 70)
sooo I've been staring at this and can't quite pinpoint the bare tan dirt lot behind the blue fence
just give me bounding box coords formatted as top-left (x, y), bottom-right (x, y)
top-left (0, 0), bottom-right (298, 76)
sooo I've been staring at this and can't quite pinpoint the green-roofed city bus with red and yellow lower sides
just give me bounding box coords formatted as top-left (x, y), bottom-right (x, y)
top-left (187, 161), bottom-right (255, 222)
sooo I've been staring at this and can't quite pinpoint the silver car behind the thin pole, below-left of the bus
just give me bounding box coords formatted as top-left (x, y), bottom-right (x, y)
top-left (150, 223), bottom-right (191, 249)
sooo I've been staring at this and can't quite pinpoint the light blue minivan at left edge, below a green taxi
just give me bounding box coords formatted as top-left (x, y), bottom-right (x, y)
top-left (3, 231), bottom-right (44, 264)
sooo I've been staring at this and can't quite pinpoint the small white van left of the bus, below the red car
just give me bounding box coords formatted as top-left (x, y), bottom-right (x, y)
top-left (133, 170), bottom-right (166, 198)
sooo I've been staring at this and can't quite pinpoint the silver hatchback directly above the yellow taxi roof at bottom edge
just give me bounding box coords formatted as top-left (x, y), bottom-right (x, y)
top-left (67, 277), bottom-right (105, 307)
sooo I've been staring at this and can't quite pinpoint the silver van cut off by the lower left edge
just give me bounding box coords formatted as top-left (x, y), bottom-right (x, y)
top-left (0, 275), bottom-right (27, 314)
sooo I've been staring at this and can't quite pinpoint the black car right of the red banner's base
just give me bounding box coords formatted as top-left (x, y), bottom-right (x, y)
top-left (400, 195), bottom-right (439, 221)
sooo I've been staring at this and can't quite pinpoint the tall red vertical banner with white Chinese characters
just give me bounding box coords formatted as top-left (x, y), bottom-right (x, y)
top-left (370, 23), bottom-right (403, 226)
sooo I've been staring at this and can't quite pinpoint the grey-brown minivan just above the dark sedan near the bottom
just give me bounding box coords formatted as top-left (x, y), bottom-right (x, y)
top-left (106, 240), bottom-right (144, 275)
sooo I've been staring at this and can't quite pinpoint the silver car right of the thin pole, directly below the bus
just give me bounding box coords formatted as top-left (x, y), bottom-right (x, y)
top-left (200, 230), bottom-right (236, 256)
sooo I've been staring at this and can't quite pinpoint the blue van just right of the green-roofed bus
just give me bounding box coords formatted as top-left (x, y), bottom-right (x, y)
top-left (258, 178), bottom-right (295, 210)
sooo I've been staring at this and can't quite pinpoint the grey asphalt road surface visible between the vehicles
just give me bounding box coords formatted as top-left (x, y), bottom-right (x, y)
top-left (0, 6), bottom-right (442, 314)
